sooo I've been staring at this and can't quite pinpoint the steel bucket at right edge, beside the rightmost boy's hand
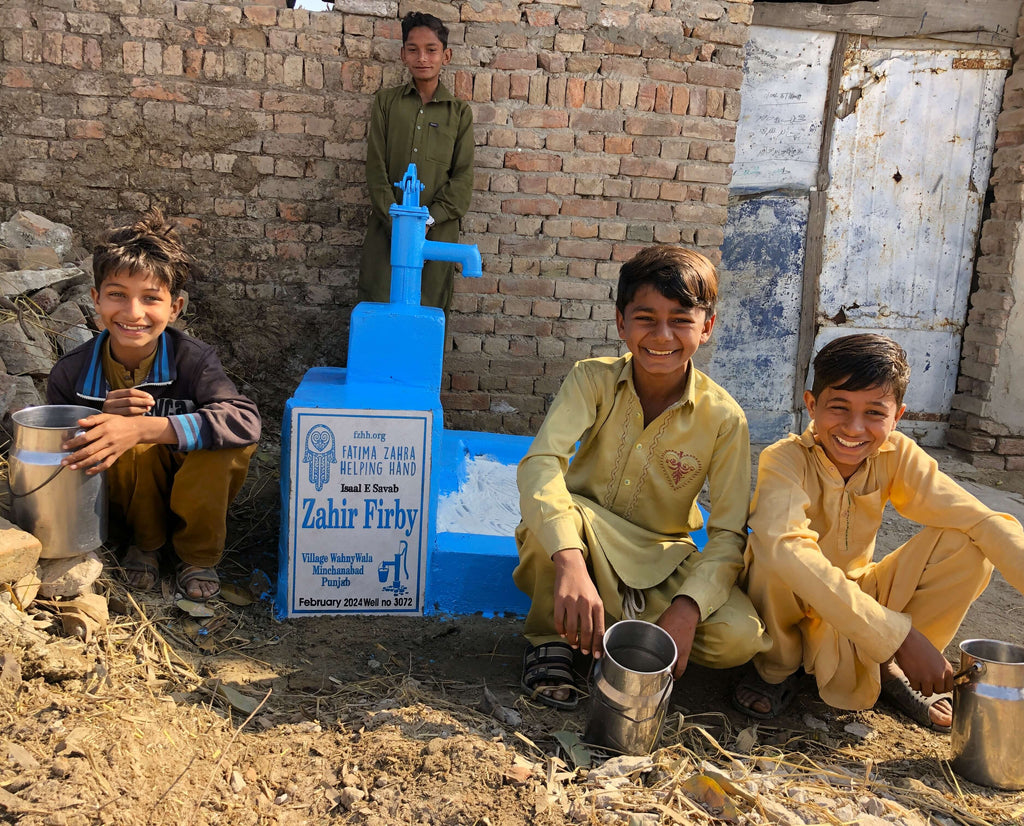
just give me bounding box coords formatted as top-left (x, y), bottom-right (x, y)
top-left (950, 640), bottom-right (1024, 789)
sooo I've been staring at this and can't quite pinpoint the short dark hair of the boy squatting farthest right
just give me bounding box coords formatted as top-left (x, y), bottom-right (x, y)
top-left (811, 333), bottom-right (910, 404)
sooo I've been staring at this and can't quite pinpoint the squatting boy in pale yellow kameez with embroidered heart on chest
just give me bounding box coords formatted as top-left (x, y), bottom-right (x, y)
top-left (513, 246), bottom-right (768, 708)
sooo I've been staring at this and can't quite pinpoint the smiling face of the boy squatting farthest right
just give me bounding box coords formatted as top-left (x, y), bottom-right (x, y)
top-left (804, 384), bottom-right (906, 479)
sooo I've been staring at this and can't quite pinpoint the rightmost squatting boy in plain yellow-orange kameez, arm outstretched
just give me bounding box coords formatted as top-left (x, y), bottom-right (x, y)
top-left (733, 334), bottom-right (1024, 732)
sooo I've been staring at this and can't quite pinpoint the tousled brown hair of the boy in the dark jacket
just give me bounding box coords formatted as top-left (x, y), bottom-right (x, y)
top-left (92, 208), bottom-right (195, 298)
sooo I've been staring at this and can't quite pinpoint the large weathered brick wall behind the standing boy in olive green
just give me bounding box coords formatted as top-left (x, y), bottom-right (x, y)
top-left (0, 0), bottom-right (752, 433)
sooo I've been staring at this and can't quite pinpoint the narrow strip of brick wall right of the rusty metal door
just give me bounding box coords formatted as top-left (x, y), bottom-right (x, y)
top-left (947, 4), bottom-right (1024, 470)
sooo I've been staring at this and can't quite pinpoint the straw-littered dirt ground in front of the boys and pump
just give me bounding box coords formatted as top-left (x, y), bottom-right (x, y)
top-left (0, 446), bottom-right (1024, 826)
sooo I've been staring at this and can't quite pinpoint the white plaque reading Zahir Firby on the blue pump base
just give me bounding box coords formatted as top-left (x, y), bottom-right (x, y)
top-left (287, 407), bottom-right (432, 614)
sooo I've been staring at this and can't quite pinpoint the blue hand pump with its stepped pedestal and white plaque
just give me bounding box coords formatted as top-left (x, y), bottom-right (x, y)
top-left (275, 165), bottom-right (481, 616)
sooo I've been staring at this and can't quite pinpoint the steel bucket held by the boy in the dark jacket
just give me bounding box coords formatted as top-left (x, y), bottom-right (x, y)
top-left (7, 404), bottom-right (106, 559)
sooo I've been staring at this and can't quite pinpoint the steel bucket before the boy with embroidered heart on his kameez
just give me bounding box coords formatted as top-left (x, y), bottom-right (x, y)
top-left (584, 619), bottom-right (677, 754)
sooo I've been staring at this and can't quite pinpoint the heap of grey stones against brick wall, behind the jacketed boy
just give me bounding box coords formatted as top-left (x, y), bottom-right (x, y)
top-left (0, 211), bottom-right (96, 425)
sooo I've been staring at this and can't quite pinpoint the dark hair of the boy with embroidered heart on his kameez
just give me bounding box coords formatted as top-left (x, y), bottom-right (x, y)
top-left (615, 244), bottom-right (718, 315)
